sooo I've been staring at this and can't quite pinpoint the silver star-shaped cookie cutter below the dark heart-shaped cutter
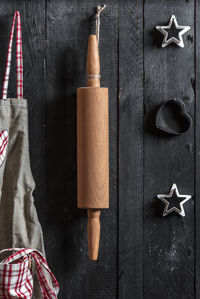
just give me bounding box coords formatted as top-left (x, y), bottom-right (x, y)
top-left (157, 184), bottom-right (192, 217)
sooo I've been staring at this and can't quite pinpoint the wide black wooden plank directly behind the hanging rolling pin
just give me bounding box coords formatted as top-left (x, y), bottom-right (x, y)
top-left (45, 0), bottom-right (118, 299)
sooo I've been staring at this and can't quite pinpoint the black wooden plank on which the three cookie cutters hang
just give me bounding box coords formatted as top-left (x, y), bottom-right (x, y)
top-left (144, 0), bottom-right (195, 299)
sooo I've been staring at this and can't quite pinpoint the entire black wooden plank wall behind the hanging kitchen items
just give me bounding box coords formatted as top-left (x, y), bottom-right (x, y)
top-left (0, 0), bottom-right (200, 299)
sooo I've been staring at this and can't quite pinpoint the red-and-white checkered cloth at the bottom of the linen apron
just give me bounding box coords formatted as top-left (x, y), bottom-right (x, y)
top-left (0, 248), bottom-right (59, 299)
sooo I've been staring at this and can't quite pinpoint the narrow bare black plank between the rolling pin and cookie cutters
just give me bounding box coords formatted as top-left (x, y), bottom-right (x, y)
top-left (118, 0), bottom-right (143, 299)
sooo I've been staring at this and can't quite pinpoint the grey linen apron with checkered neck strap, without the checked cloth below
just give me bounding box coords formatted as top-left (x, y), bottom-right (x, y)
top-left (0, 11), bottom-right (45, 299)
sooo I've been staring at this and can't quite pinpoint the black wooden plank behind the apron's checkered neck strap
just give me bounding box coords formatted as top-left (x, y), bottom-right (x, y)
top-left (0, 0), bottom-right (45, 224)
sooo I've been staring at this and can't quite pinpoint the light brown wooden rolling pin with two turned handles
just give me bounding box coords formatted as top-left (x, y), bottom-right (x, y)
top-left (77, 34), bottom-right (109, 260)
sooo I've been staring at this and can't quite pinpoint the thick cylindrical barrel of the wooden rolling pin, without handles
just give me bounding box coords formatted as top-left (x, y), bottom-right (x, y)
top-left (77, 87), bottom-right (109, 209)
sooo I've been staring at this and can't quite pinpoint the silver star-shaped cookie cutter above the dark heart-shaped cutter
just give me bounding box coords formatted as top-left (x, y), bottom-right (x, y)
top-left (156, 15), bottom-right (190, 48)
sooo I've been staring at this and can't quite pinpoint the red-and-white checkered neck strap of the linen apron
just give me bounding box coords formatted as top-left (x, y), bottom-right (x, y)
top-left (2, 10), bottom-right (23, 100)
